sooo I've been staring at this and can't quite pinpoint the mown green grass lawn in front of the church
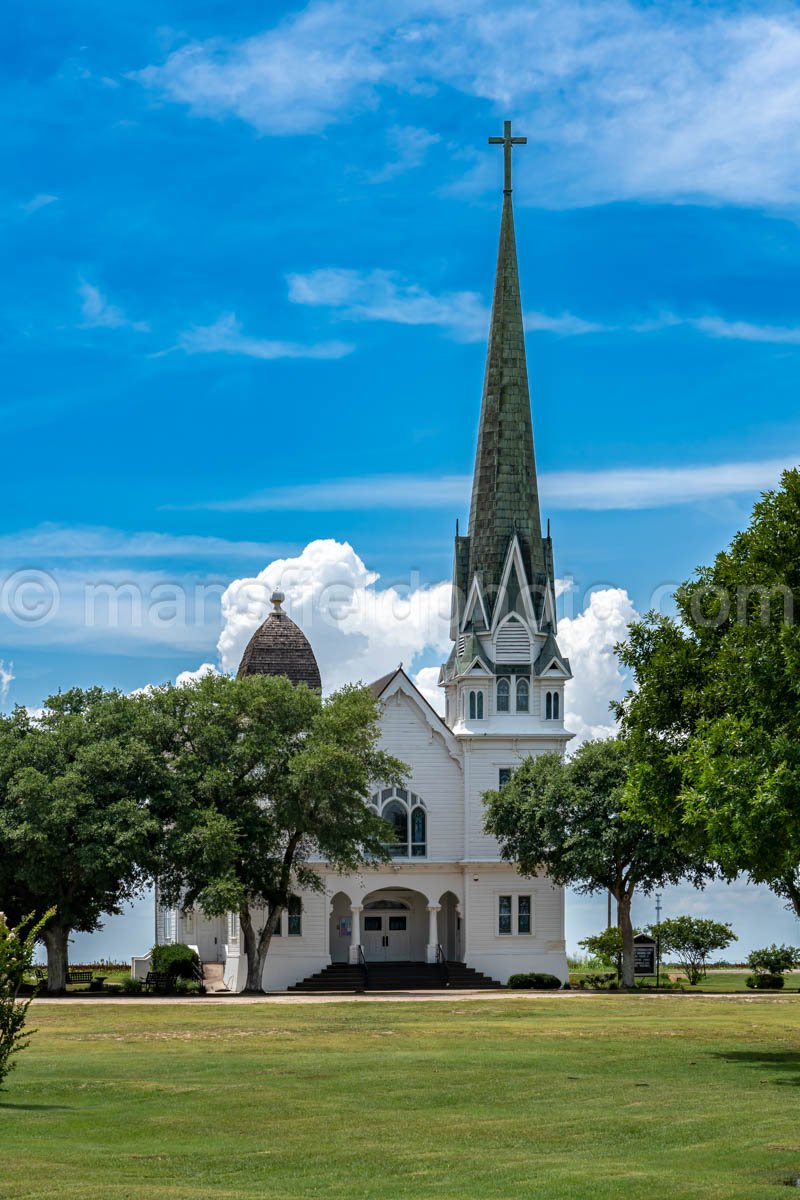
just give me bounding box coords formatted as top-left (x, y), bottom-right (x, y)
top-left (0, 995), bottom-right (800, 1200)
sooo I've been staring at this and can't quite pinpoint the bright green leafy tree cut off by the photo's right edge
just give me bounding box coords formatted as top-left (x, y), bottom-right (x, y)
top-left (616, 469), bottom-right (800, 916)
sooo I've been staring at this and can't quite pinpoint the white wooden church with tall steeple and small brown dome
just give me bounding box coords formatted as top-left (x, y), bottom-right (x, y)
top-left (151, 122), bottom-right (572, 991)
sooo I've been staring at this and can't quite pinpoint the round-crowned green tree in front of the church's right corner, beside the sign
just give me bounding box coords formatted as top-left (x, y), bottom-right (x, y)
top-left (483, 739), bottom-right (709, 988)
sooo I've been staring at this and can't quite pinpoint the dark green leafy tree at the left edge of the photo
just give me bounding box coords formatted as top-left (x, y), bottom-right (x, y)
top-left (0, 688), bottom-right (168, 992)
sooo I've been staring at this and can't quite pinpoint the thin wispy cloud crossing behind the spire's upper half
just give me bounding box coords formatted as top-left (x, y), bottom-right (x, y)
top-left (287, 266), bottom-right (604, 342)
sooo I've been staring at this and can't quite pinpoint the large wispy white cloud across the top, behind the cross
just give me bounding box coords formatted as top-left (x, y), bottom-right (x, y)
top-left (134, 0), bottom-right (800, 205)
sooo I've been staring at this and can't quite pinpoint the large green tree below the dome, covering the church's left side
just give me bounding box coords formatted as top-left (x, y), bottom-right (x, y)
top-left (152, 676), bottom-right (408, 991)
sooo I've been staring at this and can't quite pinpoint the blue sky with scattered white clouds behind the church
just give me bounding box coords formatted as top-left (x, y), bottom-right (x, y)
top-left (0, 0), bottom-right (800, 955)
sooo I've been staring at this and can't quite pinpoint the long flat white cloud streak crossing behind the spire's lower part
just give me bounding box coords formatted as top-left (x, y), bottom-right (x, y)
top-left (190, 455), bottom-right (800, 512)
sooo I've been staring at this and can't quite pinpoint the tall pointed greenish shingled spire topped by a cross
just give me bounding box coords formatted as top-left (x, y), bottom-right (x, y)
top-left (468, 121), bottom-right (547, 602)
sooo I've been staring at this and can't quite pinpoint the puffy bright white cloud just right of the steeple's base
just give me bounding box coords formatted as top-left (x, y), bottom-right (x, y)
top-left (558, 588), bottom-right (638, 750)
